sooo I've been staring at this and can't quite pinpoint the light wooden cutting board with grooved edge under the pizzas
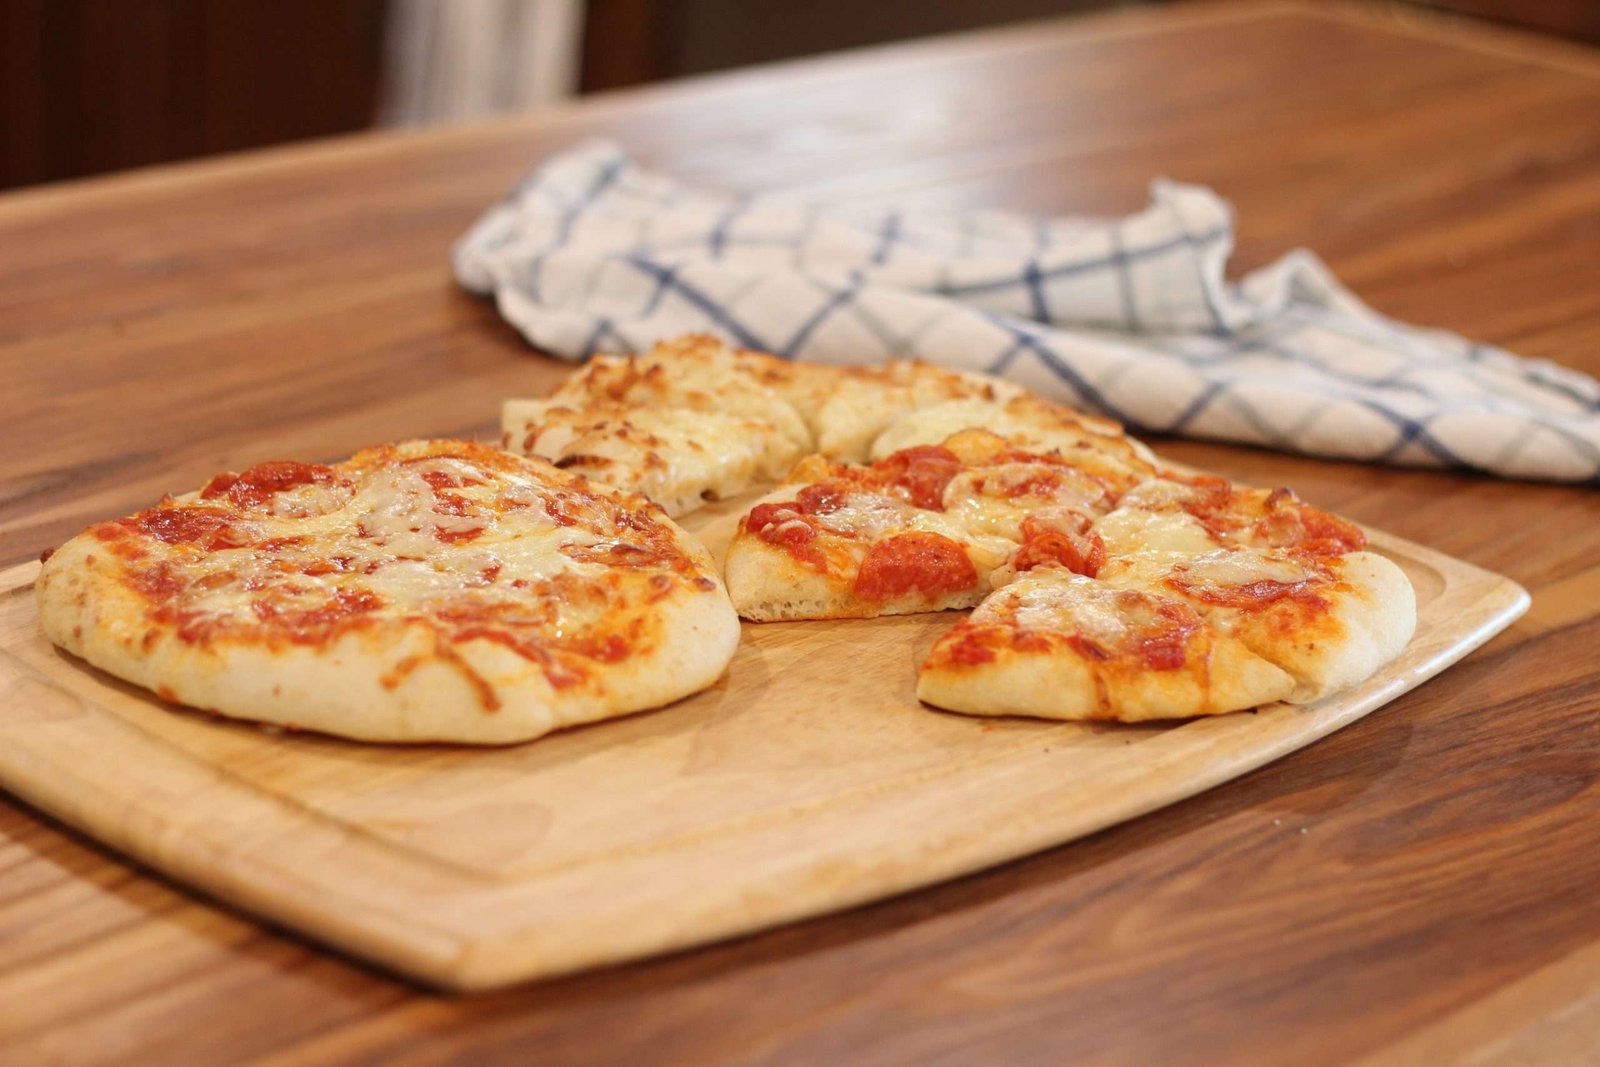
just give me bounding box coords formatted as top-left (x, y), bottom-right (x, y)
top-left (0, 507), bottom-right (1528, 989)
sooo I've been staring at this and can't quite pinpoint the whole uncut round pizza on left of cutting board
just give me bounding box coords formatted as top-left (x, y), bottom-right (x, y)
top-left (37, 442), bottom-right (739, 744)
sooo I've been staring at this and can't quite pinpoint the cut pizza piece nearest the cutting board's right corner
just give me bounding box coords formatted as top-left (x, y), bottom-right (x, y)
top-left (918, 457), bottom-right (1416, 721)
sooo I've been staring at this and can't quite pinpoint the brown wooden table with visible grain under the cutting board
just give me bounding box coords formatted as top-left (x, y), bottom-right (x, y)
top-left (0, 5), bottom-right (1600, 1065)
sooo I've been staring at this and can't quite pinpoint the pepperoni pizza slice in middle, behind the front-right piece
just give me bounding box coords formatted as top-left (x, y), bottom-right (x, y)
top-left (726, 430), bottom-right (1134, 621)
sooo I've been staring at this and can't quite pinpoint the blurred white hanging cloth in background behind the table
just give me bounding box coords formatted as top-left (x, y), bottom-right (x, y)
top-left (379, 0), bottom-right (584, 126)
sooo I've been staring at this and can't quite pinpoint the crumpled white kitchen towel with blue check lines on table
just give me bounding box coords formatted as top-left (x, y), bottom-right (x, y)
top-left (454, 144), bottom-right (1600, 485)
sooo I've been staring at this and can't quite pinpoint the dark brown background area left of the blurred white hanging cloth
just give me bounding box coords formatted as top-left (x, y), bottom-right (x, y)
top-left (0, 0), bottom-right (384, 187)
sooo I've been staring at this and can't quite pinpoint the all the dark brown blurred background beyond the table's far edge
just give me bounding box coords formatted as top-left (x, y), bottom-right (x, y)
top-left (0, 0), bottom-right (1600, 189)
